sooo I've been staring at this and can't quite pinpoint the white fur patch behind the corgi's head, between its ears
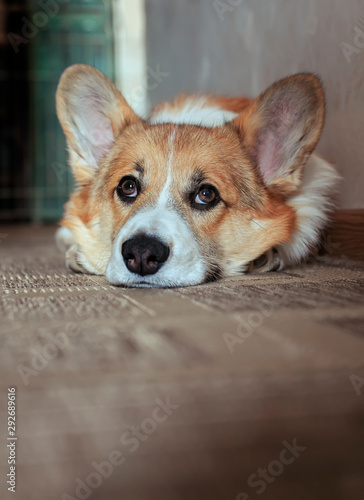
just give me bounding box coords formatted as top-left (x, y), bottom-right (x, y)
top-left (150, 96), bottom-right (238, 127)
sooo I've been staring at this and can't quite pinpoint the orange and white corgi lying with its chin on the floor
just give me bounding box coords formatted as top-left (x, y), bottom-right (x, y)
top-left (56, 65), bottom-right (340, 287)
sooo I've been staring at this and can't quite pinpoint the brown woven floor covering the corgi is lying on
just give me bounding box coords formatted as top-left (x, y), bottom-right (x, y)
top-left (0, 227), bottom-right (364, 500)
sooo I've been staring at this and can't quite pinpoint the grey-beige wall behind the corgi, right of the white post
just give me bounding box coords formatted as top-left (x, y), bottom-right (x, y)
top-left (146, 0), bottom-right (364, 208)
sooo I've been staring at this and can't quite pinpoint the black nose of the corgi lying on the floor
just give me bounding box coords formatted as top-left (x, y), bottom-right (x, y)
top-left (121, 234), bottom-right (169, 276)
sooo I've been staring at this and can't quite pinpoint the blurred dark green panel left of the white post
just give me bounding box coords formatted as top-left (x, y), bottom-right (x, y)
top-left (29, 0), bottom-right (114, 221)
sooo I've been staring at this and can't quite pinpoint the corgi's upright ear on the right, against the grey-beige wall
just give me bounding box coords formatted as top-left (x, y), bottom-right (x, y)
top-left (232, 73), bottom-right (325, 195)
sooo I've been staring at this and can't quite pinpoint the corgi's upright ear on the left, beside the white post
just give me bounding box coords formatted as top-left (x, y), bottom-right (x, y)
top-left (56, 64), bottom-right (140, 184)
